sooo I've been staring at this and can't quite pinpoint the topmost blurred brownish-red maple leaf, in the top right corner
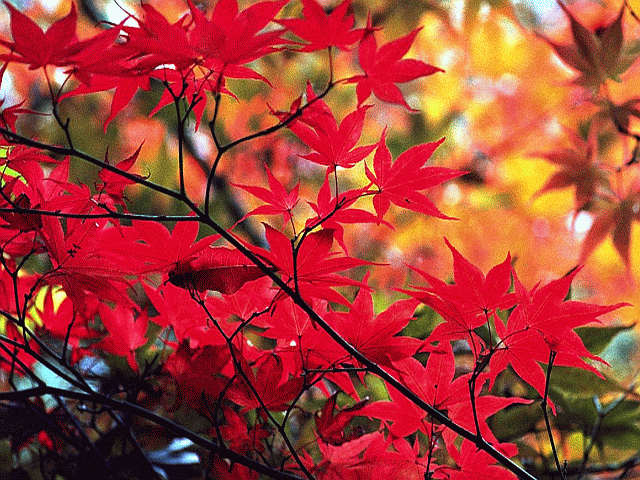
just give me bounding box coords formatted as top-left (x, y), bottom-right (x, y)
top-left (539, 1), bottom-right (632, 88)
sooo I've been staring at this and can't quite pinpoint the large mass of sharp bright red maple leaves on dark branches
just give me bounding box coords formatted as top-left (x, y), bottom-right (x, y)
top-left (0, 0), bottom-right (621, 479)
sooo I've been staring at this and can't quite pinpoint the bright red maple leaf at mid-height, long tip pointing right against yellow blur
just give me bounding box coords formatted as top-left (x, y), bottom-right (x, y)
top-left (365, 130), bottom-right (466, 221)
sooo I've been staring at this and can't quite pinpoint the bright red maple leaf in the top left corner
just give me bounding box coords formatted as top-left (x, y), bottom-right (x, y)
top-left (0, 1), bottom-right (78, 69)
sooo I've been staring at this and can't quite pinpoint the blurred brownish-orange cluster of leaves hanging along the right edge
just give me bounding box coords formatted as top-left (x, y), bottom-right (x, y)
top-left (539, 1), bottom-right (640, 267)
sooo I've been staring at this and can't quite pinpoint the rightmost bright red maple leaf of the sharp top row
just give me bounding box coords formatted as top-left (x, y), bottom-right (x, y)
top-left (346, 18), bottom-right (444, 112)
